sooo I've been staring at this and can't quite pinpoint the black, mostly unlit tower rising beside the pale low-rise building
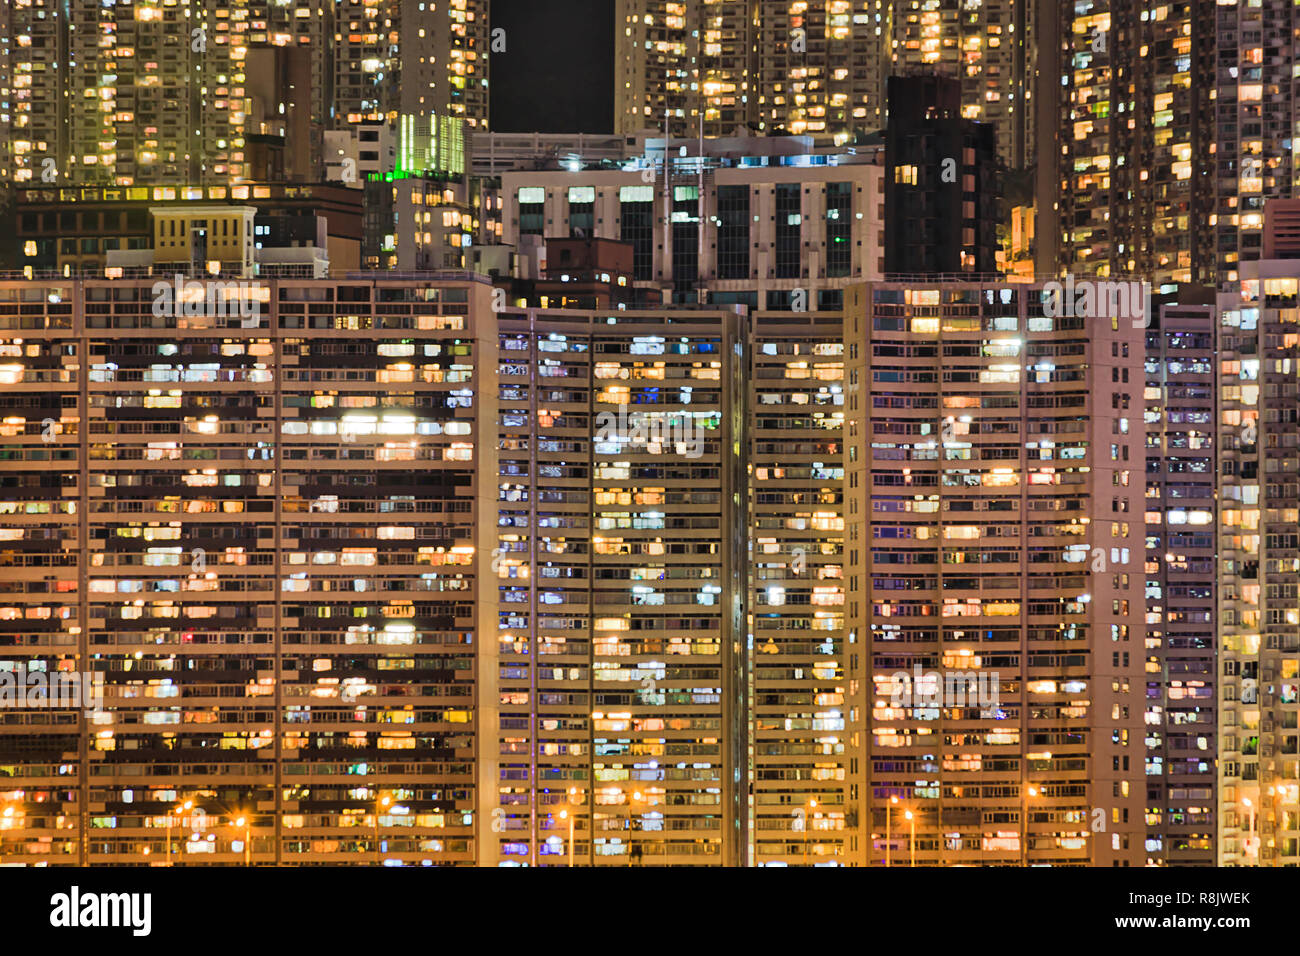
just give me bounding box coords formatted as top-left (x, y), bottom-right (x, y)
top-left (885, 75), bottom-right (998, 274)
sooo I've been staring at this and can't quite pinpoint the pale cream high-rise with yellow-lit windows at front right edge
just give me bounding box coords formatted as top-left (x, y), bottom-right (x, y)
top-left (1217, 260), bottom-right (1300, 866)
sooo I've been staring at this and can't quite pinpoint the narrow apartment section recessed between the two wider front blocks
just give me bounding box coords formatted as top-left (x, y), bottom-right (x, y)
top-left (748, 312), bottom-right (857, 866)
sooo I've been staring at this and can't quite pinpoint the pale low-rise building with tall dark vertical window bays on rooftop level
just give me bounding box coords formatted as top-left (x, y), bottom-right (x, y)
top-left (502, 139), bottom-right (884, 311)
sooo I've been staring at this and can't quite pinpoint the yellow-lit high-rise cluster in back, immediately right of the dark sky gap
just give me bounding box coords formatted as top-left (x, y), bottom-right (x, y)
top-left (615, 0), bottom-right (1039, 168)
